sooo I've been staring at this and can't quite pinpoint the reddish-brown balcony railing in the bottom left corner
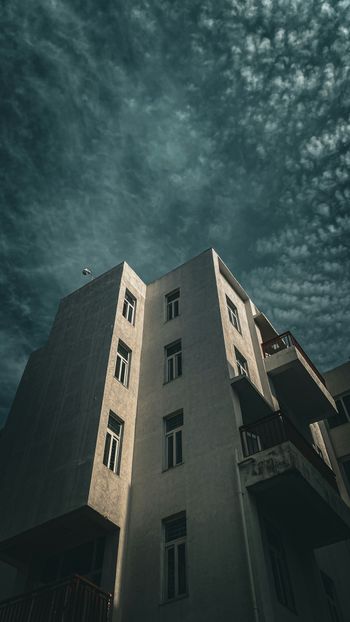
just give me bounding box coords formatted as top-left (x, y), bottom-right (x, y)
top-left (0, 576), bottom-right (112, 622)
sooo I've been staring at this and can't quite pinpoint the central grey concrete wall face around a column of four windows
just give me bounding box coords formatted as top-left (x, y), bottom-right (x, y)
top-left (122, 251), bottom-right (253, 622)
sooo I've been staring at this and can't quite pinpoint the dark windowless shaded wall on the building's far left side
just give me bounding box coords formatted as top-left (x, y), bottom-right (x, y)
top-left (0, 265), bottom-right (123, 552)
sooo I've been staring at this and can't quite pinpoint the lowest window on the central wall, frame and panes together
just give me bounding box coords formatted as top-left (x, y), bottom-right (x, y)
top-left (163, 512), bottom-right (187, 600)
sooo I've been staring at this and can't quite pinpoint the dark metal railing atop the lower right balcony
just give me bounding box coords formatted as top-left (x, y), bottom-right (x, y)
top-left (241, 412), bottom-right (338, 492)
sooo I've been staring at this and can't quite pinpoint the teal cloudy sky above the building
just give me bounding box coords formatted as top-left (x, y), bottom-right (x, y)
top-left (0, 0), bottom-right (350, 421)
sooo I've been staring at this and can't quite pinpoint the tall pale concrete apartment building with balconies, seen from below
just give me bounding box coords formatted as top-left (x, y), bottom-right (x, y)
top-left (0, 249), bottom-right (350, 622)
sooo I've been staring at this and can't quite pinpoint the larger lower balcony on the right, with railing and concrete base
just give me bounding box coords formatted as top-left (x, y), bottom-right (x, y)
top-left (240, 412), bottom-right (350, 548)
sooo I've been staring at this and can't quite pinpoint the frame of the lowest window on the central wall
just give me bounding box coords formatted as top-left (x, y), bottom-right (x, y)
top-left (162, 512), bottom-right (188, 603)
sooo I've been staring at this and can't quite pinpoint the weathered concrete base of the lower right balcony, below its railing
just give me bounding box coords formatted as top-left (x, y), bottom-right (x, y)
top-left (240, 441), bottom-right (350, 548)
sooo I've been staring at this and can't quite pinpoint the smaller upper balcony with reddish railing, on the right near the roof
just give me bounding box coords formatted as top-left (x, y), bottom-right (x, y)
top-left (262, 332), bottom-right (337, 424)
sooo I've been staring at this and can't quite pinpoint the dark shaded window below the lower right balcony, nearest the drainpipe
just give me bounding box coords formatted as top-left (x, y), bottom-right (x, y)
top-left (265, 523), bottom-right (295, 612)
